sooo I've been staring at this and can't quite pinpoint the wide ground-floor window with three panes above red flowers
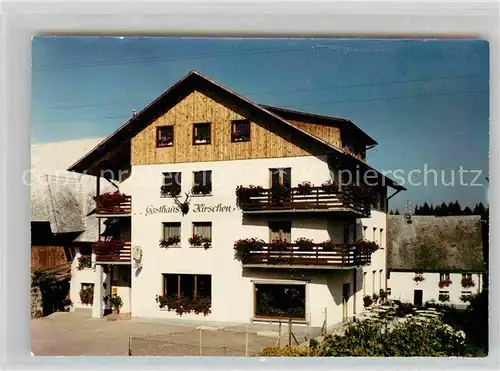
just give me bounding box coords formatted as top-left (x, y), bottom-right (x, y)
top-left (163, 273), bottom-right (212, 299)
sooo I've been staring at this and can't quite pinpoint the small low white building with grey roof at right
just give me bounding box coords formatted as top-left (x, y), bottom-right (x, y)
top-left (387, 215), bottom-right (487, 307)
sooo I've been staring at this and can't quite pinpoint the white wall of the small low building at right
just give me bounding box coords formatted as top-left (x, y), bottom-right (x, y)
top-left (388, 272), bottom-right (483, 306)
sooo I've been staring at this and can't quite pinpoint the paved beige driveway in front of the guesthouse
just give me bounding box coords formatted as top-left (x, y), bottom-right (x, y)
top-left (31, 311), bottom-right (317, 356)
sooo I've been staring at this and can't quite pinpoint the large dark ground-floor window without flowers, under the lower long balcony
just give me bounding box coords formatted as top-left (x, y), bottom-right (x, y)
top-left (255, 283), bottom-right (306, 319)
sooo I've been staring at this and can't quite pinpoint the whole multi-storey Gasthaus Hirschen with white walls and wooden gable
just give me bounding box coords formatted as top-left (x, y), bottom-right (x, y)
top-left (69, 72), bottom-right (404, 327)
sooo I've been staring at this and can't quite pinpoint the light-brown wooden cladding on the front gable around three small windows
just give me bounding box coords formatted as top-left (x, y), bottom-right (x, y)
top-left (131, 90), bottom-right (325, 165)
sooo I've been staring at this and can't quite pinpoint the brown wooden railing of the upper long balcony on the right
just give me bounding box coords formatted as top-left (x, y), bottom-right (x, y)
top-left (237, 187), bottom-right (370, 217)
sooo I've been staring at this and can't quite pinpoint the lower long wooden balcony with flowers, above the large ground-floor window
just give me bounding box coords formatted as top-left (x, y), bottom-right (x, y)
top-left (235, 240), bottom-right (378, 269)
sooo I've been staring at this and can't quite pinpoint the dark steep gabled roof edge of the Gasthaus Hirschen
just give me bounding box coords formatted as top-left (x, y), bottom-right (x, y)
top-left (68, 71), bottom-right (404, 189)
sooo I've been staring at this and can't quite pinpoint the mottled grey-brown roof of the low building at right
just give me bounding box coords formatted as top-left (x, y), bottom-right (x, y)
top-left (387, 215), bottom-right (484, 271)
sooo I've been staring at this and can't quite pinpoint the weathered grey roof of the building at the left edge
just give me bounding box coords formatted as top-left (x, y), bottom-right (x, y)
top-left (31, 138), bottom-right (114, 242)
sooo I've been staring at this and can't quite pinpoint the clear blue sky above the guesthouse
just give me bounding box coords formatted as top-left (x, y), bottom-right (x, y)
top-left (31, 37), bottom-right (489, 210)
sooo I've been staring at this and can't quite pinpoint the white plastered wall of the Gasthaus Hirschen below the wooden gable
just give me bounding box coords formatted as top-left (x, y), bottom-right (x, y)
top-left (120, 156), bottom-right (386, 326)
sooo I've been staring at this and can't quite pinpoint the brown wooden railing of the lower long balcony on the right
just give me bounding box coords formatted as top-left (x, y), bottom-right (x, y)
top-left (237, 244), bottom-right (372, 268)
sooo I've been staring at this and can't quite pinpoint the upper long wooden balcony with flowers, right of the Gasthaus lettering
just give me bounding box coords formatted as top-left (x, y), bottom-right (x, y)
top-left (236, 186), bottom-right (371, 217)
